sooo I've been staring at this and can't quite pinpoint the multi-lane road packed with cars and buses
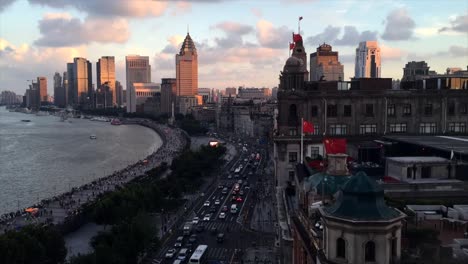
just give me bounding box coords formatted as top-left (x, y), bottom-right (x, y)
top-left (151, 138), bottom-right (273, 264)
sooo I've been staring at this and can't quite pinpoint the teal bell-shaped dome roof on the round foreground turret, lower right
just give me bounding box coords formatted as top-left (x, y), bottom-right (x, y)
top-left (325, 171), bottom-right (401, 221)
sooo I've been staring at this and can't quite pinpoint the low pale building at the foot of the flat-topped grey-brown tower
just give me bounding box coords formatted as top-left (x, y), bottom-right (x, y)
top-left (127, 83), bottom-right (161, 113)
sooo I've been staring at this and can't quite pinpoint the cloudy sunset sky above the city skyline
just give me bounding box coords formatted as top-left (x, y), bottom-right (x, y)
top-left (0, 0), bottom-right (468, 95)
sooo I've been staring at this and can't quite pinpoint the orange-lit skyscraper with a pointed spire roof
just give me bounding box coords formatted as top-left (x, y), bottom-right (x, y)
top-left (176, 33), bottom-right (198, 96)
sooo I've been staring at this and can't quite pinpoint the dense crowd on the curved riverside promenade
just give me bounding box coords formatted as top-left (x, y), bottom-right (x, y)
top-left (0, 119), bottom-right (188, 234)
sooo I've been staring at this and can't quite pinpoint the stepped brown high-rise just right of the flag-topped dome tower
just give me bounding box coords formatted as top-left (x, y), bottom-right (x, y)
top-left (310, 43), bottom-right (344, 81)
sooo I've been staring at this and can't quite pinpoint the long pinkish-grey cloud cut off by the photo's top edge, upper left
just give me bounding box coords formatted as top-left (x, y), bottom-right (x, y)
top-left (28, 0), bottom-right (168, 17)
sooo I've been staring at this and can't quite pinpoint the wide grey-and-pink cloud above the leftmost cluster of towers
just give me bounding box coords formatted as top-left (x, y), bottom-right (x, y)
top-left (34, 13), bottom-right (130, 47)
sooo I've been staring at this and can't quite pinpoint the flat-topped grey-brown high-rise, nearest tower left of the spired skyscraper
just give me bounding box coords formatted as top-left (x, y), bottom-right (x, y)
top-left (125, 55), bottom-right (151, 112)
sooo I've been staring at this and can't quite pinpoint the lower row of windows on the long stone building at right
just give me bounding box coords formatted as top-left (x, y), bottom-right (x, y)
top-left (289, 122), bottom-right (466, 136)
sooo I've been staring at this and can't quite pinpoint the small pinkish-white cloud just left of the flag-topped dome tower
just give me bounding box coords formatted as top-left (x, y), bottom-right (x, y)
top-left (257, 19), bottom-right (292, 48)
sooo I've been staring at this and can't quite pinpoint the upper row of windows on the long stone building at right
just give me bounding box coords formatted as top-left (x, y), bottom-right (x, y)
top-left (311, 103), bottom-right (468, 117)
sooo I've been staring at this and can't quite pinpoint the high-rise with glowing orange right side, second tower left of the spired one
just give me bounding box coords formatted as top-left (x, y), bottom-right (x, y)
top-left (96, 56), bottom-right (117, 106)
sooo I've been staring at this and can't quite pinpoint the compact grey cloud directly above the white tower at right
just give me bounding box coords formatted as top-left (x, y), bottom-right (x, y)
top-left (382, 8), bottom-right (416, 40)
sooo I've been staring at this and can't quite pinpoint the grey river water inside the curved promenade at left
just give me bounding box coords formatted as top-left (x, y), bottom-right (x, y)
top-left (0, 107), bottom-right (162, 215)
